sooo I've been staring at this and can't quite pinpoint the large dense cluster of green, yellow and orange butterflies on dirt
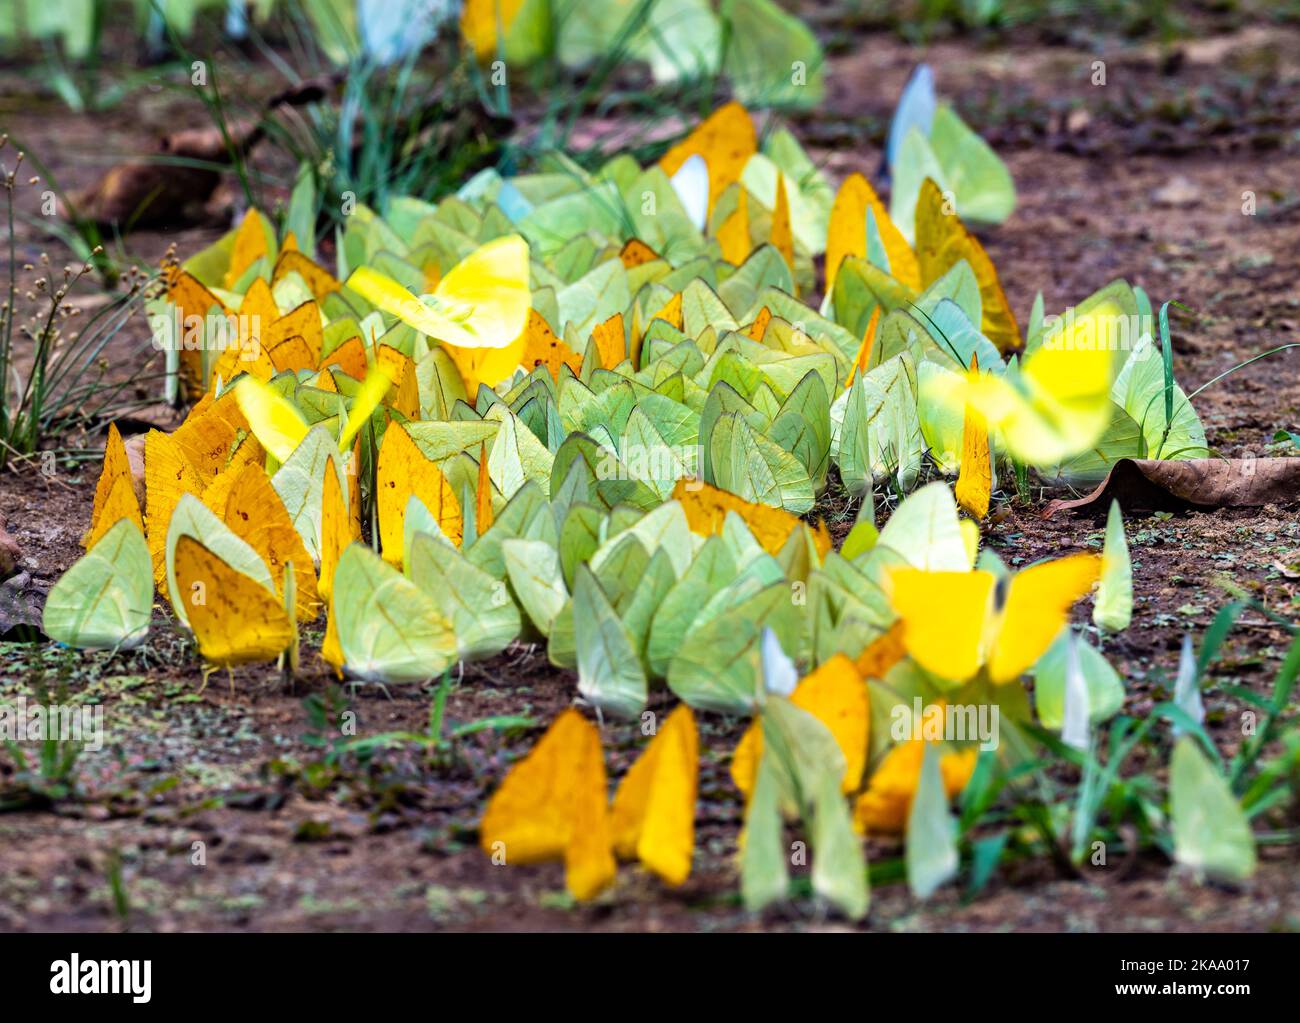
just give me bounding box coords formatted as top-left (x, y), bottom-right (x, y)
top-left (44, 74), bottom-right (1222, 915)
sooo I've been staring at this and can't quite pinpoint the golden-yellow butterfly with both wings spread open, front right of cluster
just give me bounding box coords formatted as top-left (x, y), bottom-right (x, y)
top-left (888, 554), bottom-right (1101, 682)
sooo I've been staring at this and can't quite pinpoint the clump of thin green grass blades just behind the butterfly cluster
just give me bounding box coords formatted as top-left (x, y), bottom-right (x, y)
top-left (169, 0), bottom-right (720, 248)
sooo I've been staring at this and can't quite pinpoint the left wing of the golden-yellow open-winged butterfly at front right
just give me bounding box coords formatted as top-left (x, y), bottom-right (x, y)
top-left (889, 568), bottom-right (995, 681)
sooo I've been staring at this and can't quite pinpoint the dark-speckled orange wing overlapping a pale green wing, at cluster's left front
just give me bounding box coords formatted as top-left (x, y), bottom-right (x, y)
top-left (176, 536), bottom-right (294, 668)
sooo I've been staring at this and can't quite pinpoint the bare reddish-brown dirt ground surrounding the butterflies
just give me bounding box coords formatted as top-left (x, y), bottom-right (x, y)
top-left (0, 19), bottom-right (1300, 931)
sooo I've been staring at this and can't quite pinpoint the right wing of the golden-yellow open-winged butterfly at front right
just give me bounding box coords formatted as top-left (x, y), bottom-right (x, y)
top-left (988, 554), bottom-right (1101, 682)
